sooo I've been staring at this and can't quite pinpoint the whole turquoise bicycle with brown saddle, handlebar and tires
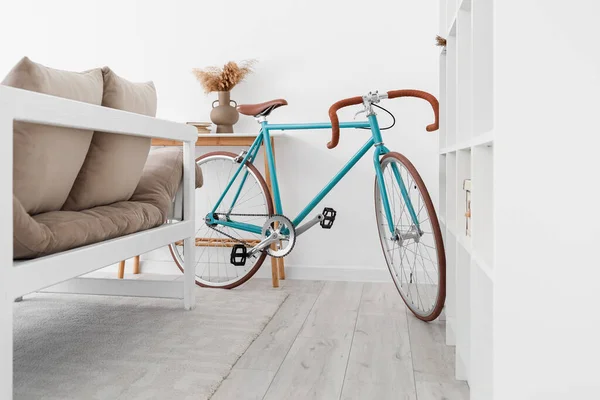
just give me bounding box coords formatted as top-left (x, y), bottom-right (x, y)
top-left (170, 90), bottom-right (446, 321)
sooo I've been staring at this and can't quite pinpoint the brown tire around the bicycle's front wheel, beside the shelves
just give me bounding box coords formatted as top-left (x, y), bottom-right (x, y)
top-left (375, 151), bottom-right (446, 322)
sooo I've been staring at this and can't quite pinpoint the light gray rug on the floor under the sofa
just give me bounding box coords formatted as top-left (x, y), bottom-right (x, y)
top-left (14, 290), bottom-right (287, 400)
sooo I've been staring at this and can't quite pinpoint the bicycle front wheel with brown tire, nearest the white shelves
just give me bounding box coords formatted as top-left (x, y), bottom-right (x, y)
top-left (375, 152), bottom-right (446, 321)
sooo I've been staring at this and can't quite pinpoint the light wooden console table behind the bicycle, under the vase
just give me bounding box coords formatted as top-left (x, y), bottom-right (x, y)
top-left (152, 132), bottom-right (285, 287)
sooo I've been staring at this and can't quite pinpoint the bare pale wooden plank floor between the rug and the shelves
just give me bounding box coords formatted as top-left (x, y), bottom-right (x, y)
top-left (212, 279), bottom-right (469, 400)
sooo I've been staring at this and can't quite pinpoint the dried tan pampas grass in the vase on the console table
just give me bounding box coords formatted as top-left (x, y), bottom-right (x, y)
top-left (192, 60), bottom-right (256, 93)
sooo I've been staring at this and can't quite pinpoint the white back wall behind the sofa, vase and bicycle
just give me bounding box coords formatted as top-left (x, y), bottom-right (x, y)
top-left (0, 0), bottom-right (439, 280)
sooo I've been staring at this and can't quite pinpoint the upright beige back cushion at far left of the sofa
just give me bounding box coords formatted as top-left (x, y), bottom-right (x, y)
top-left (2, 57), bottom-right (103, 215)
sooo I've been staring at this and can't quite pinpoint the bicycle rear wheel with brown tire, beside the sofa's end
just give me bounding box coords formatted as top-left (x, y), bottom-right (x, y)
top-left (169, 151), bottom-right (273, 289)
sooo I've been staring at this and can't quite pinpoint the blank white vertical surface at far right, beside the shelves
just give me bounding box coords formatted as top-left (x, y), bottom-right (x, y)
top-left (494, 0), bottom-right (600, 400)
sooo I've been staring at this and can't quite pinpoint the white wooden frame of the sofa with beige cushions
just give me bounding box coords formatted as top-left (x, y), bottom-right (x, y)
top-left (0, 85), bottom-right (197, 399)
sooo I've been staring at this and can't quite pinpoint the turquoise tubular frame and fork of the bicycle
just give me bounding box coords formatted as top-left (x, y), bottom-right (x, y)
top-left (206, 114), bottom-right (420, 236)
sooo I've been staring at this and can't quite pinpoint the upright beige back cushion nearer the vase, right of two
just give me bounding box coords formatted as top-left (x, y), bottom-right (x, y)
top-left (63, 67), bottom-right (156, 211)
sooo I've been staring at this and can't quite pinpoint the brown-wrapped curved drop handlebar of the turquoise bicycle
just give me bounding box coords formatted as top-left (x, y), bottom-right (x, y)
top-left (327, 89), bottom-right (440, 149)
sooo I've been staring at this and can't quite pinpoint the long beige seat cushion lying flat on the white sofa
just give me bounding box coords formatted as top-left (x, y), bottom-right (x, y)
top-left (13, 148), bottom-right (202, 259)
